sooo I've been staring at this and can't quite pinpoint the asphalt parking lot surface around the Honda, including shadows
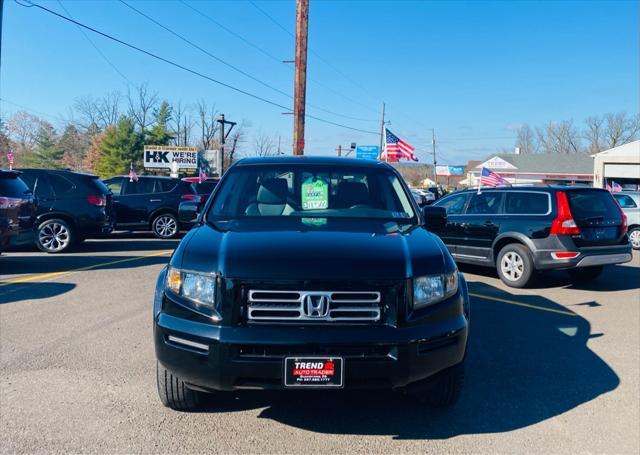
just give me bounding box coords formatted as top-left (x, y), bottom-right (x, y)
top-left (0, 235), bottom-right (640, 453)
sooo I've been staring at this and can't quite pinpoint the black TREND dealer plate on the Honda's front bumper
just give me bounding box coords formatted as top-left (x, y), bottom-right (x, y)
top-left (284, 357), bottom-right (344, 387)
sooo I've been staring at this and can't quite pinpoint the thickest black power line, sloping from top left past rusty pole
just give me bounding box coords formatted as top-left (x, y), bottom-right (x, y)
top-left (18, 3), bottom-right (378, 135)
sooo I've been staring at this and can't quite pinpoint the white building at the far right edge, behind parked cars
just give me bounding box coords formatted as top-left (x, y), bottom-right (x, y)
top-left (592, 141), bottom-right (640, 190)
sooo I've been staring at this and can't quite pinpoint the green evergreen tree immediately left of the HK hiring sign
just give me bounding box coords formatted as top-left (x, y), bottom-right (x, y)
top-left (96, 117), bottom-right (143, 178)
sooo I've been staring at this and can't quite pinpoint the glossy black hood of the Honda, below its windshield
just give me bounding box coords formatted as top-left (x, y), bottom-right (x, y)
top-left (171, 220), bottom-right (455, 280)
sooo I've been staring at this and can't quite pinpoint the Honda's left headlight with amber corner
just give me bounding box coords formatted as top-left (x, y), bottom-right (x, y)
top-left (167, 267), bottom-right (216, 310)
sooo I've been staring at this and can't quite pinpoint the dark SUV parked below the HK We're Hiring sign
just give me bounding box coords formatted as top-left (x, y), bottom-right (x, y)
top-left (104, 176), bottom-right (197, 239)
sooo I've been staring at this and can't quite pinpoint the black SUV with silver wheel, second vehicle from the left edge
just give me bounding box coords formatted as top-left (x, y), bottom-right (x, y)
top-left (21, 169), bottom-right (113, 253)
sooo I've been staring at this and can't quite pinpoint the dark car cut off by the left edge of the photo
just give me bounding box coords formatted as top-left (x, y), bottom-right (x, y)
top-left (0, 169), bottom-right (35, 253)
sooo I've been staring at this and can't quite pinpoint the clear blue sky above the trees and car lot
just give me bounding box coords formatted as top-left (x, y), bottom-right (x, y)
top-left (0, 0), bottom-right (640, 164)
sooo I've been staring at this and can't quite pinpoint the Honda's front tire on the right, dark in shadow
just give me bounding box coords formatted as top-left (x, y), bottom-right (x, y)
top-left (408, 361), bottom-right (464, 408)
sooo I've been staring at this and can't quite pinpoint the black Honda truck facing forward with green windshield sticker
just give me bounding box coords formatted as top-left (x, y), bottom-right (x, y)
top-left (153, 157), bottom-right (469, 409)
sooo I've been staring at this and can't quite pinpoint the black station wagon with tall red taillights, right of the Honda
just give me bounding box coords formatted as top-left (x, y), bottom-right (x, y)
top-left (434, 186), bottom-right (631, 287)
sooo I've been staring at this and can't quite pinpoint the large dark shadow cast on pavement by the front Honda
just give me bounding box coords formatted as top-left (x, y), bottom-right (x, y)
top-left (196, 283), bottom-right (620, 439)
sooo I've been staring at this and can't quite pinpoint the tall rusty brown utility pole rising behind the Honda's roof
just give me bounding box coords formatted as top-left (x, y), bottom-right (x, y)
top-left (293, 0), bottom-right (309, 155)
